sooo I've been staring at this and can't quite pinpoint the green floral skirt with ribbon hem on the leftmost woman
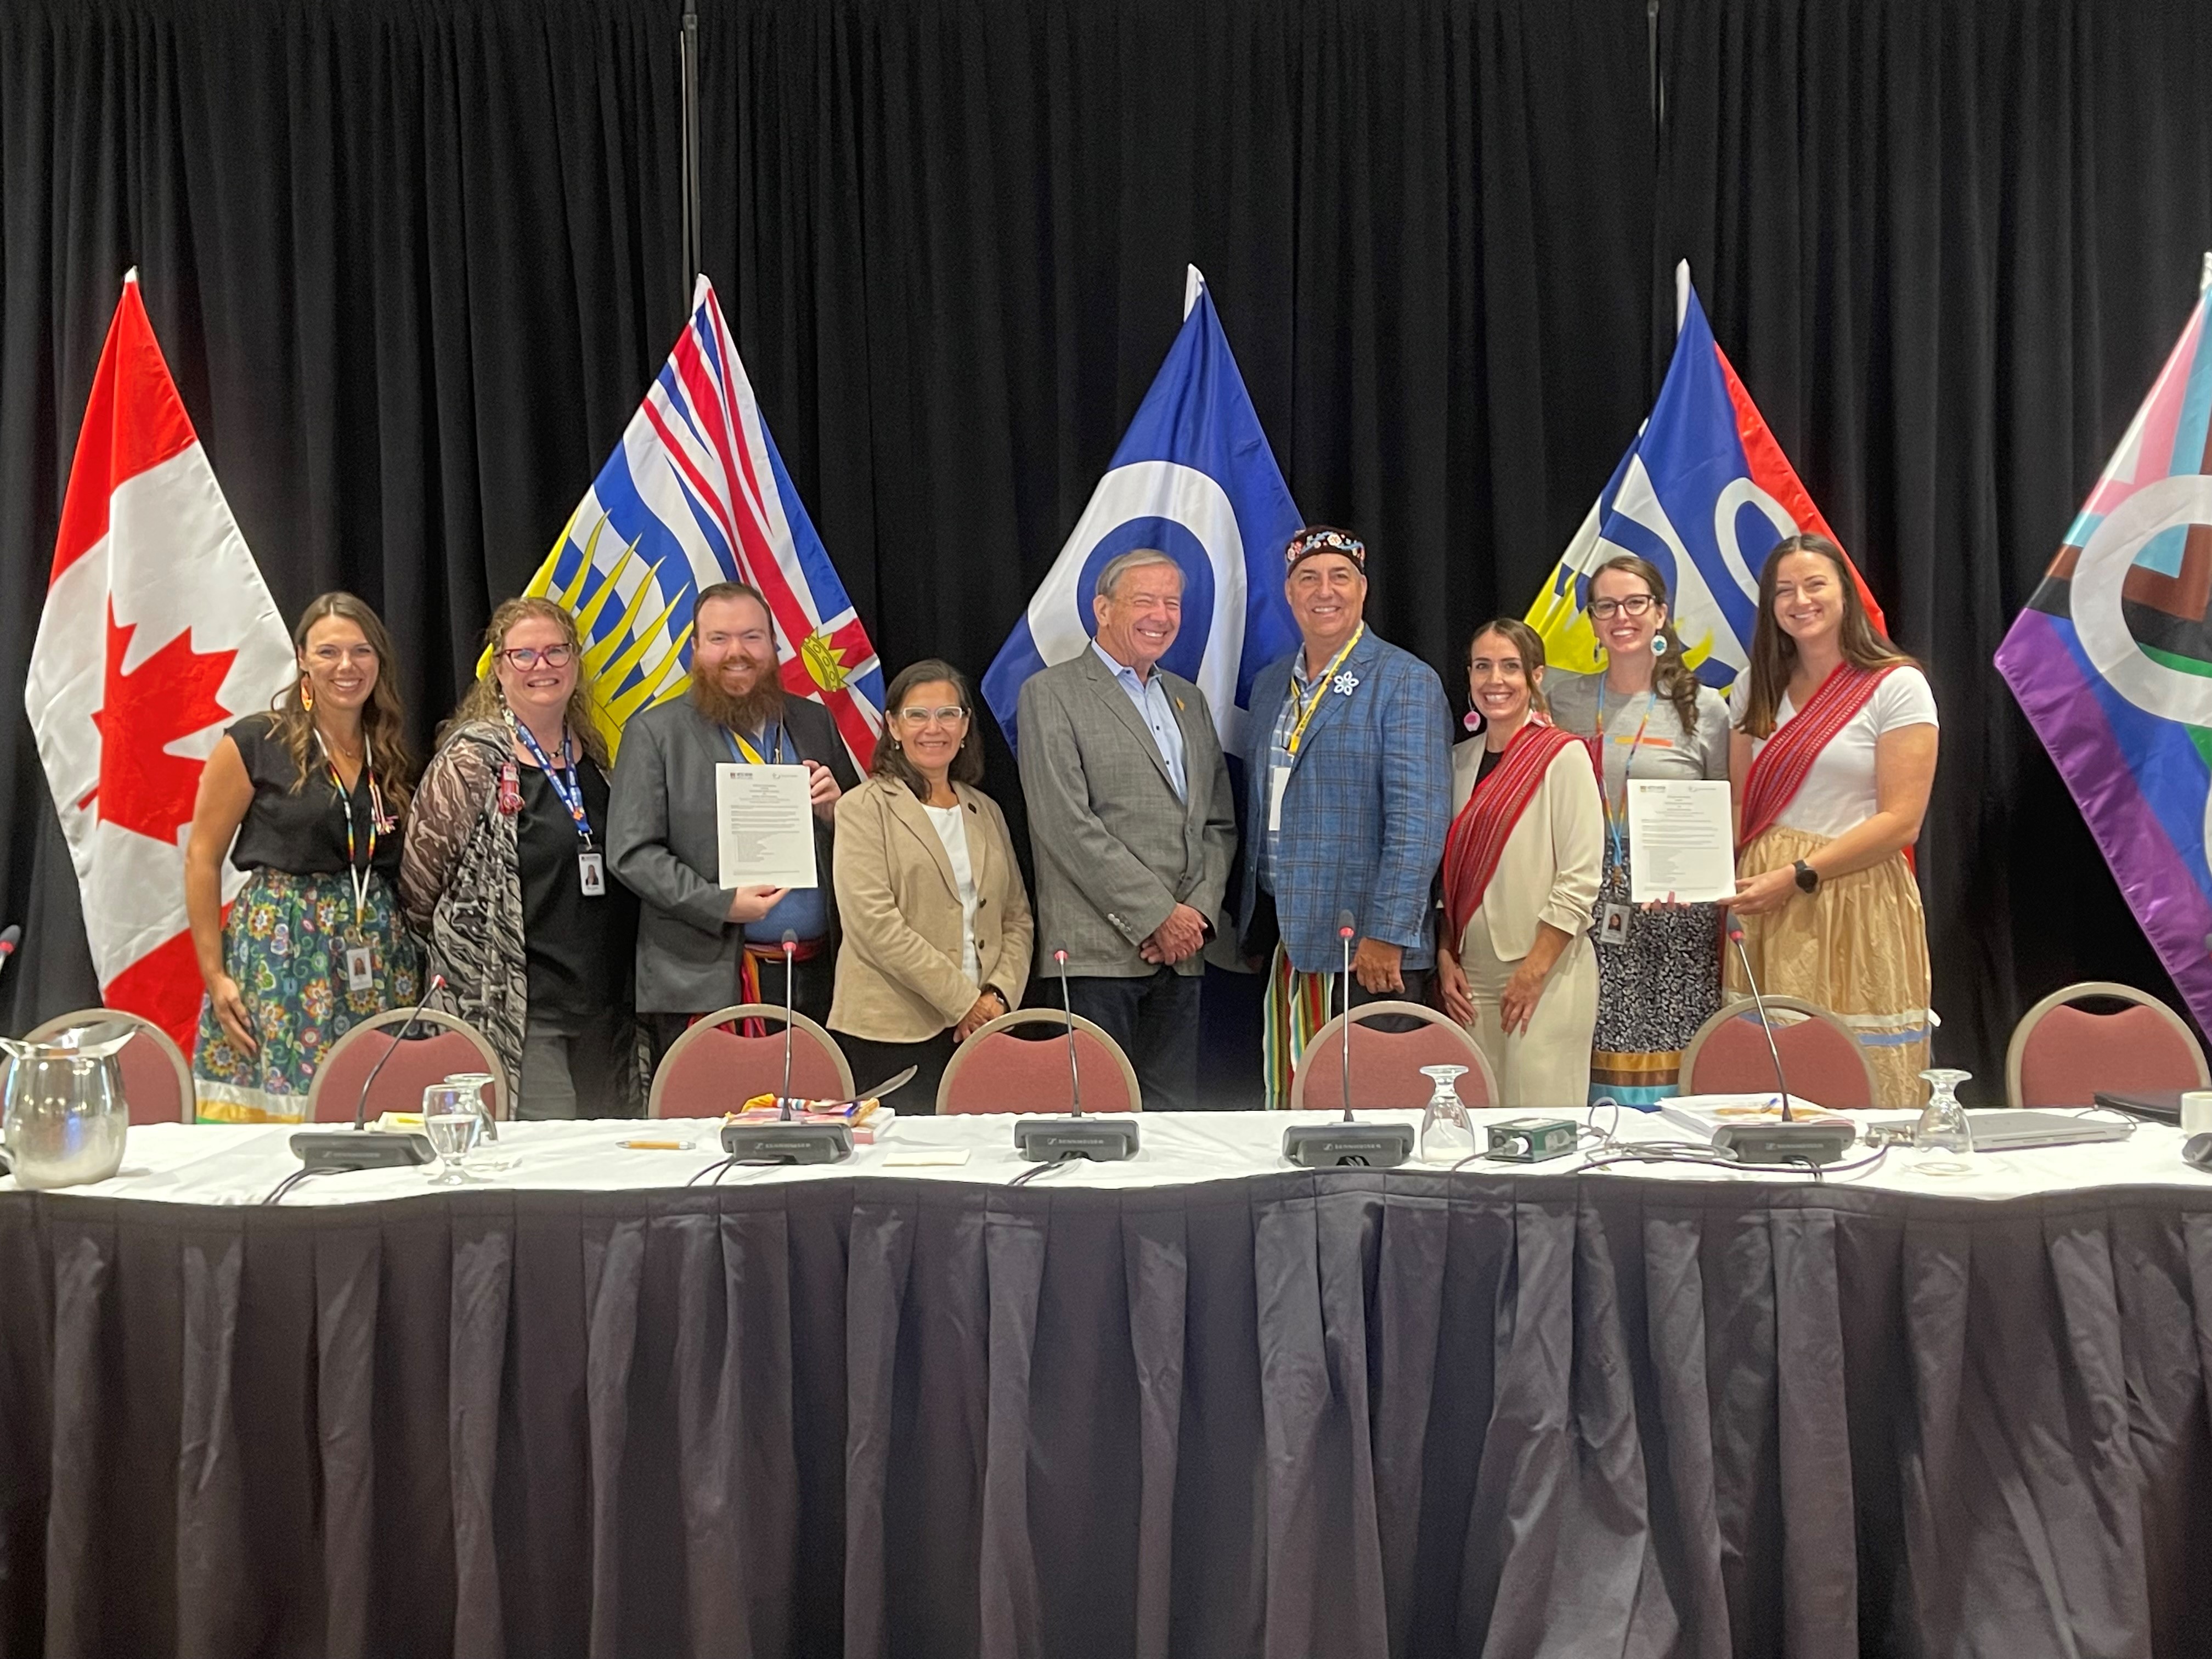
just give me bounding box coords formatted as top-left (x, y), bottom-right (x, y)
top-left (193, 870), bottom-right (422, 1124)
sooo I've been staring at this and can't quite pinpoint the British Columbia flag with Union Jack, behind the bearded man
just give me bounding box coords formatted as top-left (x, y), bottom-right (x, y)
top-left (524, 276), bottom-right (883, 772)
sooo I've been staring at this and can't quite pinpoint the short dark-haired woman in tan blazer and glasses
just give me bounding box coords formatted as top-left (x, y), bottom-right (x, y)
top-left (830, 659), bottom-right (1033, 1115)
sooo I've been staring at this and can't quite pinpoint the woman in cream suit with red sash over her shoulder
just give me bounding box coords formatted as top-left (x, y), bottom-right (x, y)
top-left (1438, 619), bottom-right (1606, 1113)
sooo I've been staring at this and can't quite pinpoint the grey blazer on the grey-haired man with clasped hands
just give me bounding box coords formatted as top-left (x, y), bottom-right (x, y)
top-left (1020, 646), bottom-right (1237, 978)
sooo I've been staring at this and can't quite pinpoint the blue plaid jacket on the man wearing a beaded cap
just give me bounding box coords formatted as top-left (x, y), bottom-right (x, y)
top-left (1237, 630), bottom-right (1451, 973)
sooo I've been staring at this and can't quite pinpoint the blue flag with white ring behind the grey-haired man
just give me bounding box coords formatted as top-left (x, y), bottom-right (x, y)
top-left (982, 266), bottom-right (1301, 754)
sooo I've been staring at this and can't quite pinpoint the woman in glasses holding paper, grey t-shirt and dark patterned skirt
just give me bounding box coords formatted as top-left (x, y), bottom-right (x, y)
top-left (1544, 553), bottom-right (1728, 1110)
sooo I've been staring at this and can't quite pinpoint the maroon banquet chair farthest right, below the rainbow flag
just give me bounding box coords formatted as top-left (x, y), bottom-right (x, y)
top-left (2004, 980), bottom-right (2212, 1106)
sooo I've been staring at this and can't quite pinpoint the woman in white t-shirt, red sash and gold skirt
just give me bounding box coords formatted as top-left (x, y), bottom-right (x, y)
top-left (1723, 535), bottom-right (1936, 1106)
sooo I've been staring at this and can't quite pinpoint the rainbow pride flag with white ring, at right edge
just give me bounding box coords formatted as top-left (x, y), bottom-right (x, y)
top-left (1997, 255), bottom-right (2212, 1024)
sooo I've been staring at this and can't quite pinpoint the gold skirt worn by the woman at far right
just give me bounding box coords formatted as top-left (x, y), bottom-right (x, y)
top-left (1721, 827), bottom-right (1929, 1108)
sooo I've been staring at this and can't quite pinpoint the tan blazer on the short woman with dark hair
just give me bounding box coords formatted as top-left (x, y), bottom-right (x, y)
top-left (830, 778), bottom-right (1033, 1042)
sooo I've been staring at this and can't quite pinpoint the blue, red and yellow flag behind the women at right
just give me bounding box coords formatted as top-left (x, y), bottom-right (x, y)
top-left (1528, 263), bottom-right (1882, 688)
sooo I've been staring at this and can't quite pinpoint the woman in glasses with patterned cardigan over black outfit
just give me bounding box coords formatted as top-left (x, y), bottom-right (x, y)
top-left (400, 597), bottom-right (644, 1117)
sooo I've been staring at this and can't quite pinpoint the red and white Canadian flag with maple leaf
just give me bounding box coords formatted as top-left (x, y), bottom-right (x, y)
top-left (24, 272), bottom-right (294, 1053)
